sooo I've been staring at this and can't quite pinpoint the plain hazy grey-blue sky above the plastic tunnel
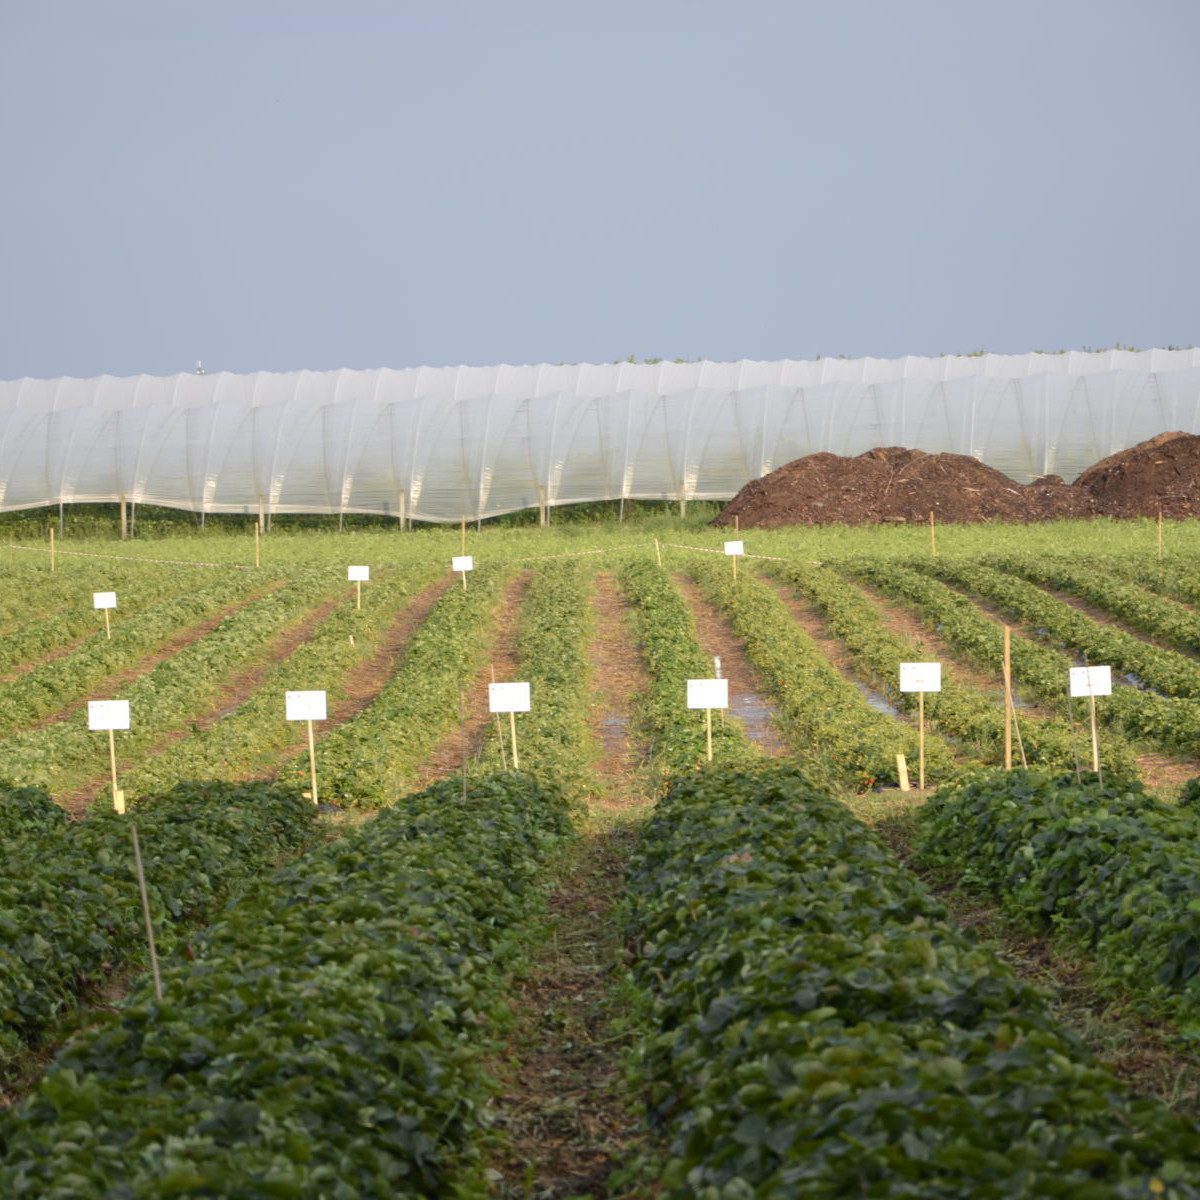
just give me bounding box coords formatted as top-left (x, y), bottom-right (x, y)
top-left (0, 0), bottom-right (1200, 378)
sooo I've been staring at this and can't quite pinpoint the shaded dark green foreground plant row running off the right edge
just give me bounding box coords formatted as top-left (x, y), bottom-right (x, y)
top-left (920, 772), bottom-right (1200, 1032)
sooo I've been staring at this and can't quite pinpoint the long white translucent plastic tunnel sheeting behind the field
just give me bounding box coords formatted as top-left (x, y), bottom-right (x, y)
top-left (0, 350), bottom-right (1200, 521)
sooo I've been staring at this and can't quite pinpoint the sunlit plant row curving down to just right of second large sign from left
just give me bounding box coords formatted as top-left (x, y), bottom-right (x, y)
top-left (304, 568), bottom-right (509, 809)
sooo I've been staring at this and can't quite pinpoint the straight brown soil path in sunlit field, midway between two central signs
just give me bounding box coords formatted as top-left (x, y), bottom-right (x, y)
top-left (592, 571), bottom-right (649, 808)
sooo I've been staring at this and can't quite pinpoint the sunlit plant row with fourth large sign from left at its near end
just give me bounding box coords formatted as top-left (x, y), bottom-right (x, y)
top-left (618, 558), bottom-right (757, 775)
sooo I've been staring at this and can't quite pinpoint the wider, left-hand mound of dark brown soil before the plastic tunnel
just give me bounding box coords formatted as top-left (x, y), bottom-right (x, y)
top-left (715, 446), bottom-right (1092, 529)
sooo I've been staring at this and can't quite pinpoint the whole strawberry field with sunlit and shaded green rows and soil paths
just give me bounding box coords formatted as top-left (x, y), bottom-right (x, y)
top-left (0, 518), bottom-right (1200, 1200)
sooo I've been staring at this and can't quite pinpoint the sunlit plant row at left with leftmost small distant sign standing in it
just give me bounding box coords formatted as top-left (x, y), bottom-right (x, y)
top-left (0, 566), bottom-right (260, 736)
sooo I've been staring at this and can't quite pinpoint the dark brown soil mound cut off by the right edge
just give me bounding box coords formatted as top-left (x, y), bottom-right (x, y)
top-left (1075, 433), bottom-right (1200, 517)
